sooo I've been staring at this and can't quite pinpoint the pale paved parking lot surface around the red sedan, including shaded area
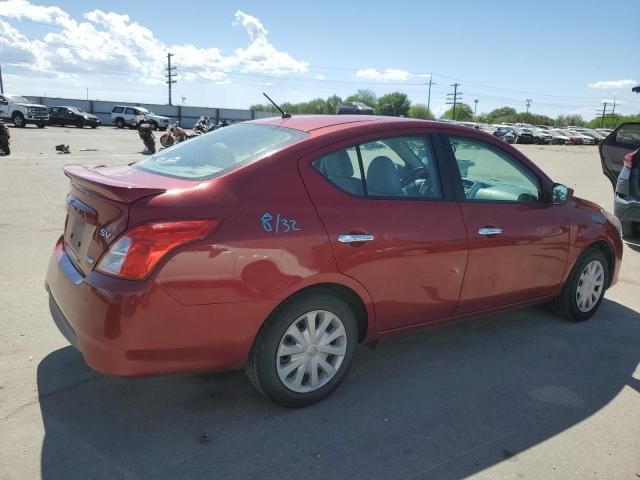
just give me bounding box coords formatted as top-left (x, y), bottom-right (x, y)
top-left (0, 127), bottom-right (640, 480)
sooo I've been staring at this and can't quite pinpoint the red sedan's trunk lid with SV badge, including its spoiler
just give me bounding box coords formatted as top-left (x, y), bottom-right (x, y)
top-left (64, 165), bottom-right (194, 275)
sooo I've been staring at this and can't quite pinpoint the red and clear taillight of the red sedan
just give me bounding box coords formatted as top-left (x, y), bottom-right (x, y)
top-left (96, 220), bottom-right (220, 280)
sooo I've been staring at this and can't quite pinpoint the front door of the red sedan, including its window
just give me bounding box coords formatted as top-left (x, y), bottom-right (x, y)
top-left (443, 133), bottom-right (569, 314)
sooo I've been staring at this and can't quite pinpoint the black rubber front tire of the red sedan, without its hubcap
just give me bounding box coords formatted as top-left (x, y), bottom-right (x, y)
top-left (551, 247), bottom-right (610, 322)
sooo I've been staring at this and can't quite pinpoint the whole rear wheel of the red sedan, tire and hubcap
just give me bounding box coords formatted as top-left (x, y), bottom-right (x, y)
top-left (245, 290), bottom-right (358, 408)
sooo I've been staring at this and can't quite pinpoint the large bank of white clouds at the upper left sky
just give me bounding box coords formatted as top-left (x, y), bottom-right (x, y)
top-left (0, 0), bottom-right (309, 84)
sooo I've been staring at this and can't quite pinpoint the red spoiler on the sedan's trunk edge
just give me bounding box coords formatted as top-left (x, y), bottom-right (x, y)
top-left (64, 165), bottom-right (167, 203)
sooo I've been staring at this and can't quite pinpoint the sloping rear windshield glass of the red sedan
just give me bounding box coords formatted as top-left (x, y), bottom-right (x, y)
top-left (134, 123), bottom-right (309, 180)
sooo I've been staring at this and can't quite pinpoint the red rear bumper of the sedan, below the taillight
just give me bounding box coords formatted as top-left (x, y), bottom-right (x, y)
top-left (45, 238), bottom-right (275, 376)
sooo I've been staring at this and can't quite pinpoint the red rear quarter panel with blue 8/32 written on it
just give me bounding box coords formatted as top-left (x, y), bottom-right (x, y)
top-left (130, 150), bottom-right (373, 331)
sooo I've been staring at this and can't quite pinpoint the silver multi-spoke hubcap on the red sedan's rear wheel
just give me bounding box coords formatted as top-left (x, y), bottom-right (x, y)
top-left (276, 310), bottom-right (347, 393)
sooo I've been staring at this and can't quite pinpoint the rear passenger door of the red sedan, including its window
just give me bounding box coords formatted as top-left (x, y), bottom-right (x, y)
top-left (301, 134), bottom-right (467, 331)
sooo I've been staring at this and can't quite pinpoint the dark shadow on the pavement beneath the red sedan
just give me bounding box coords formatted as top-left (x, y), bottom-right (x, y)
top-left (38, 301), bottom-right (640, 480)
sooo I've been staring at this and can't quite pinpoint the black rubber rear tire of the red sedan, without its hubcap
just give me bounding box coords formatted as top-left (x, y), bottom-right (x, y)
top-left (245, 289), bottom-right (358, 408)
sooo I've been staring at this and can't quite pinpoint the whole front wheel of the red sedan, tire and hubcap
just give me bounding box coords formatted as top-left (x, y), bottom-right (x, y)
top-left (551, 248), bottom-right (609, 322)
